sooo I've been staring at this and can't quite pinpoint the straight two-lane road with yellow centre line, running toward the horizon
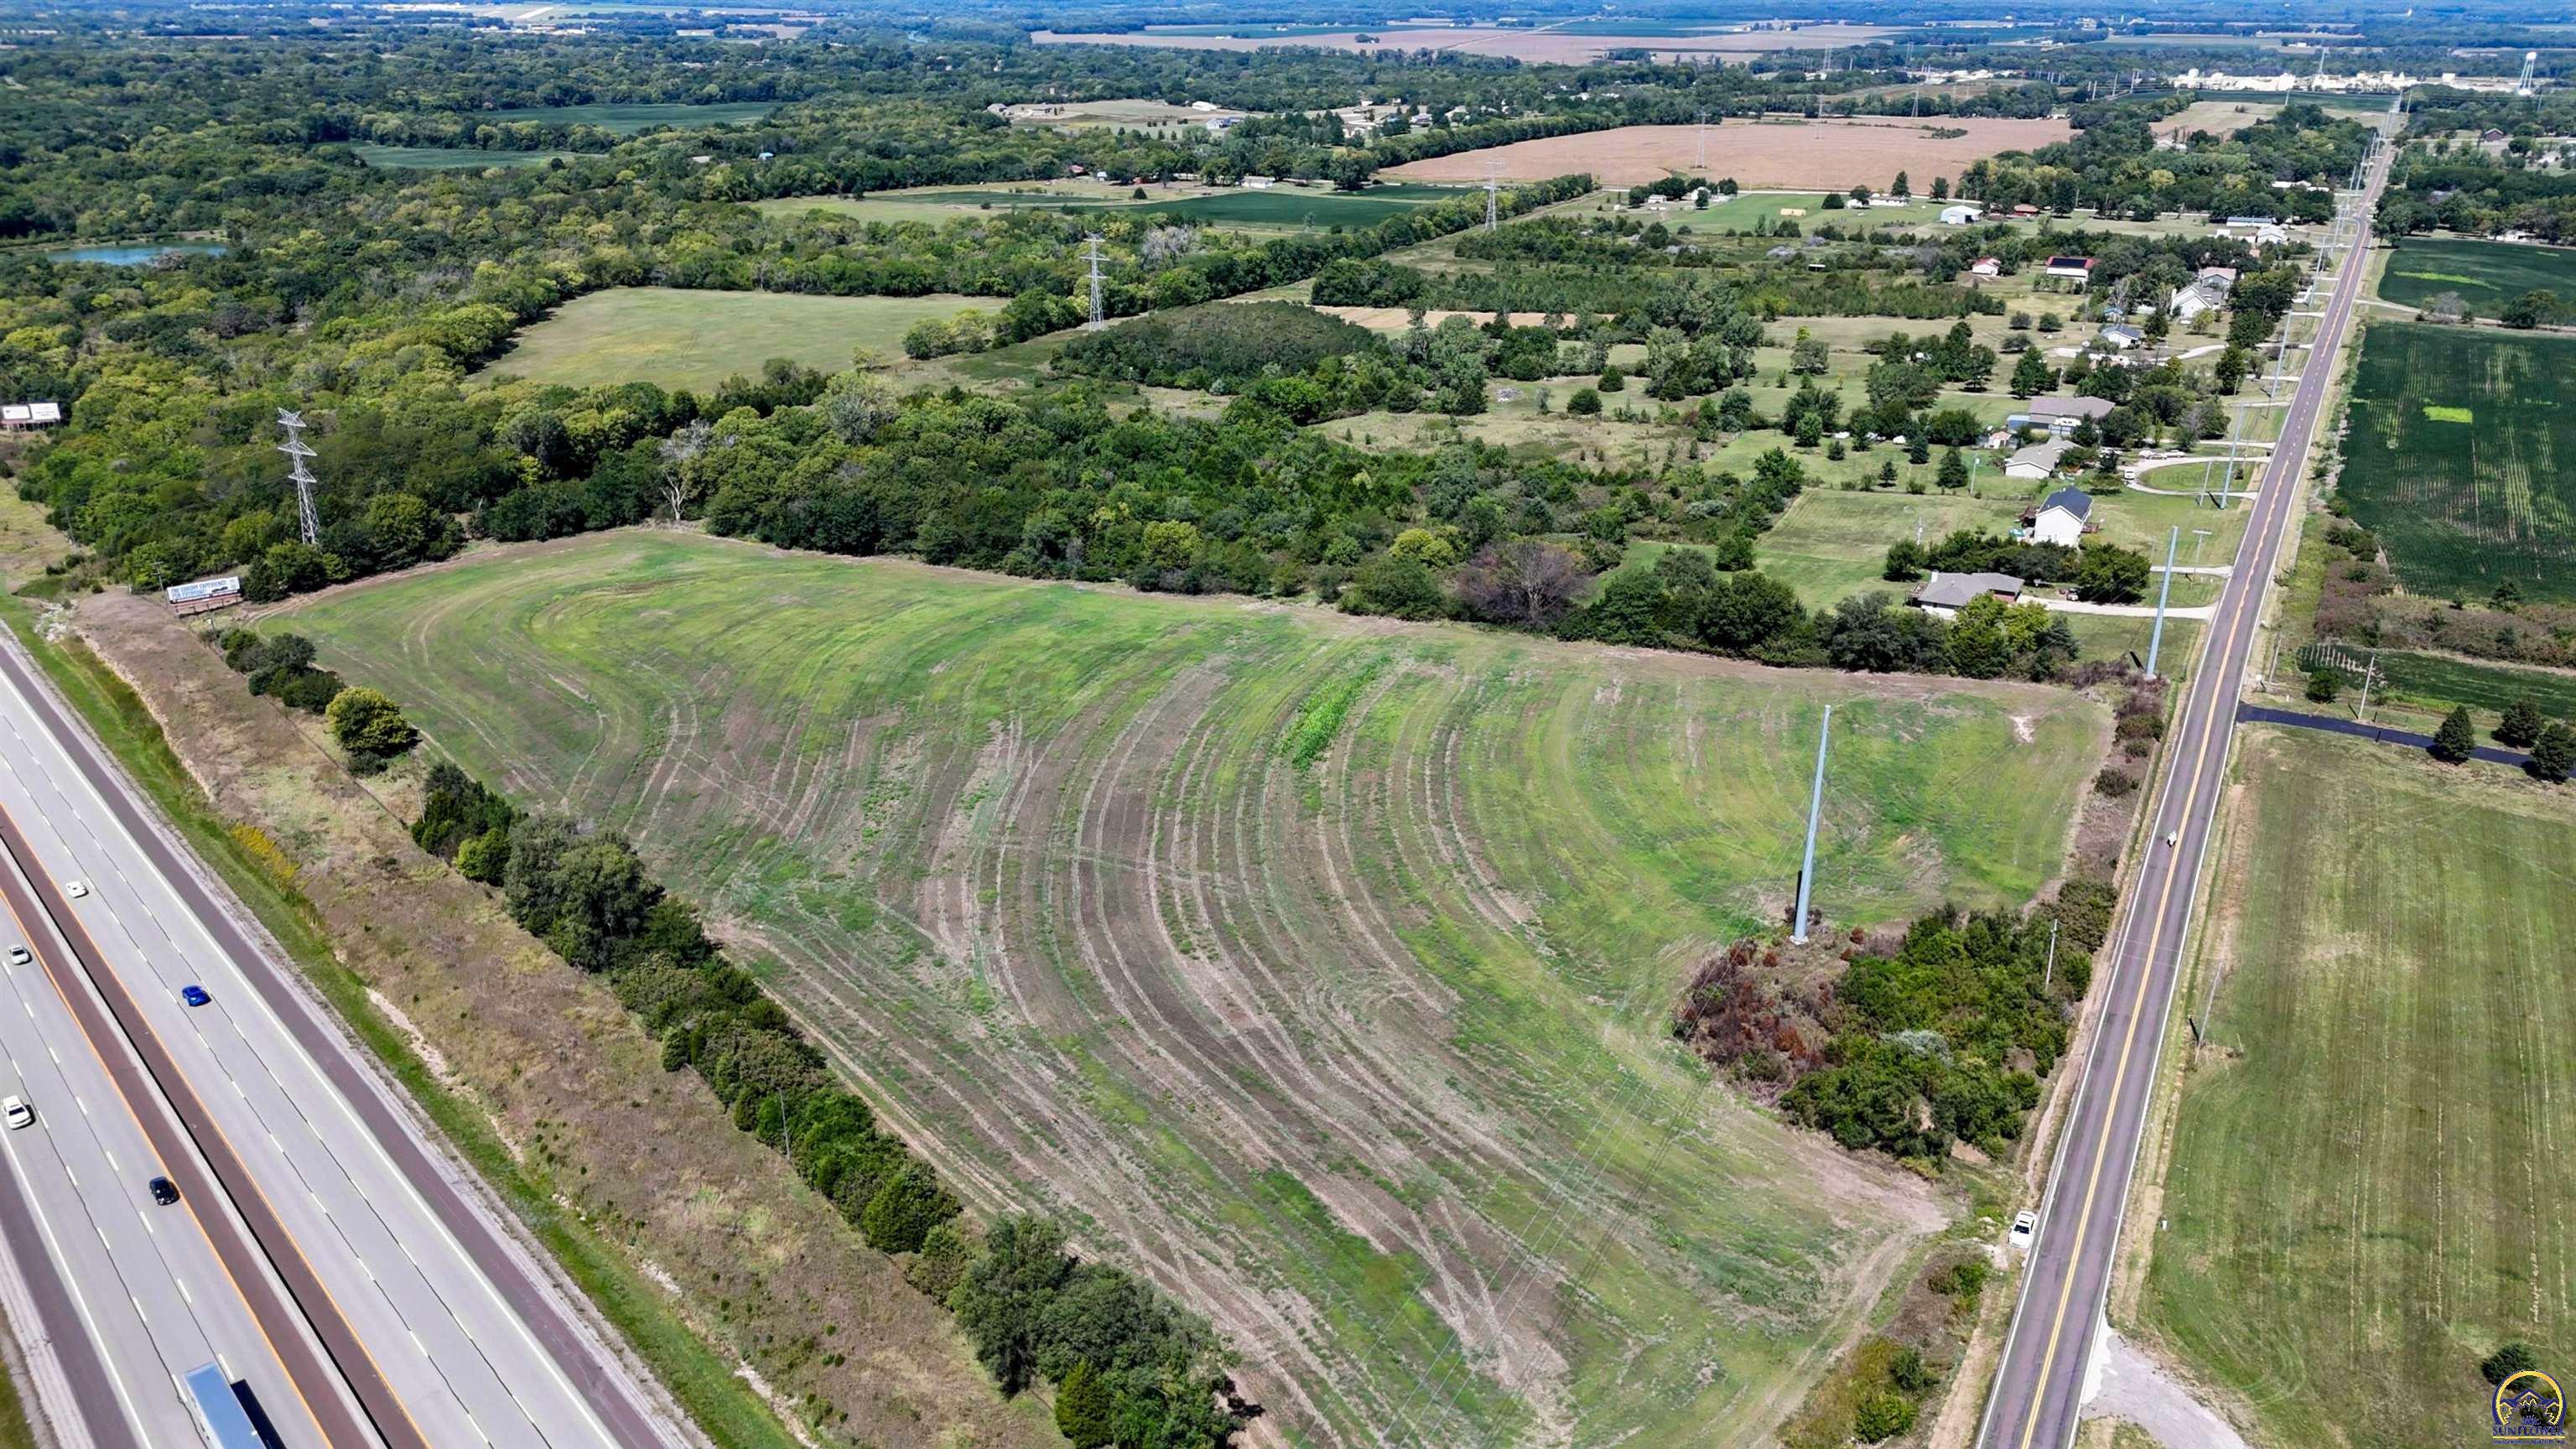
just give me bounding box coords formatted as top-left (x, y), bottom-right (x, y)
top-left (1978, 135), bottom-right (2388, 1449)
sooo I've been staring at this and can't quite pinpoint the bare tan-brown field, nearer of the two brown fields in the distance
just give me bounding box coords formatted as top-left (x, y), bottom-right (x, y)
top-left (1381, 116), bottom-right (2074, 191)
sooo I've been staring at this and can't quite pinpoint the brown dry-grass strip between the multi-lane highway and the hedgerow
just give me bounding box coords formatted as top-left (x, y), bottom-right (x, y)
top-left (77, 590), bottom-right (1059, 1449)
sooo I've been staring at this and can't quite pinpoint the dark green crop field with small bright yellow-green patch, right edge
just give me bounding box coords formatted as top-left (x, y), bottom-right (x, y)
top-left (2339, 322), bottom-right (2576, 600)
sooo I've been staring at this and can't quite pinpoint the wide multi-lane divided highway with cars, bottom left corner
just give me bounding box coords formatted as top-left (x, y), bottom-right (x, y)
top-left (0, 642), bottom-right (688, 1449)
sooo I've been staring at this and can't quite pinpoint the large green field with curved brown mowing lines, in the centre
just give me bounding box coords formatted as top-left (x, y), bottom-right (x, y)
top-left (278, 531), bottom-right (2107, 1446)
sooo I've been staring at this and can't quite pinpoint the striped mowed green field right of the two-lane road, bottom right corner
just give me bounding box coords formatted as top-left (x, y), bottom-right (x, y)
top-left (2141, 730), bottom-right (2576, 1449)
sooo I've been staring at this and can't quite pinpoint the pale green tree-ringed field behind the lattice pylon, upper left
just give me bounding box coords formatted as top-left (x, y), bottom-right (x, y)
top-left (469, 286), bottom-right (1002, 392)
